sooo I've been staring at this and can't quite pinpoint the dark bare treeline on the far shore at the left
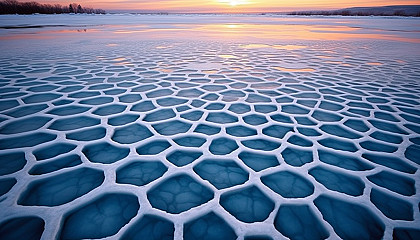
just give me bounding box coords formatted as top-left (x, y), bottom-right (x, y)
top-left (0, 0), bottom-right (105, 14)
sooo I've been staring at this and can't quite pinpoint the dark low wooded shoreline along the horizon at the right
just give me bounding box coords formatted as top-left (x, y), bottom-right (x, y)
top-left (288, 10), bottom-right (420, 17)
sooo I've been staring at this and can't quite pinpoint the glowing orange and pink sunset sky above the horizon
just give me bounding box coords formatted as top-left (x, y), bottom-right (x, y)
top-left (37, 0), bottom-right (419, 12)
